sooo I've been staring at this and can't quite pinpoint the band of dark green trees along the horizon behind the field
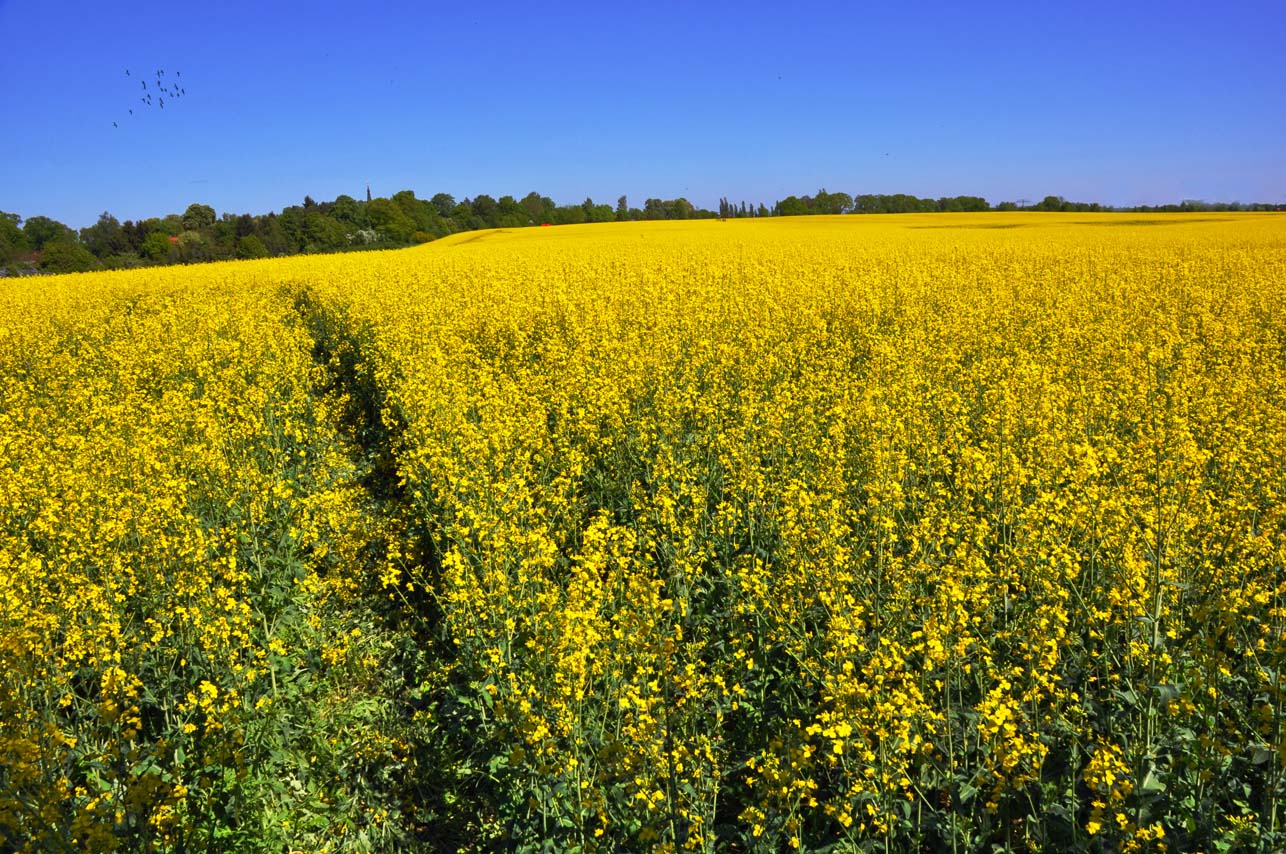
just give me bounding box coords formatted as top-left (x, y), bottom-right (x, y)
top-left (0, 189), bottom-right (1280, 275)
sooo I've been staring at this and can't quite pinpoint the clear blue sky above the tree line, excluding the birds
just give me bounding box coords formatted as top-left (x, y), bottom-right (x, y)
top-left (0, 0), bottom-right (1286, 228)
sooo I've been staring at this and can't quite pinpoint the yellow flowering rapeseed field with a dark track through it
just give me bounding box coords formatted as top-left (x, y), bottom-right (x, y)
top-left (0, 214), bottom-right (1286, 851)
